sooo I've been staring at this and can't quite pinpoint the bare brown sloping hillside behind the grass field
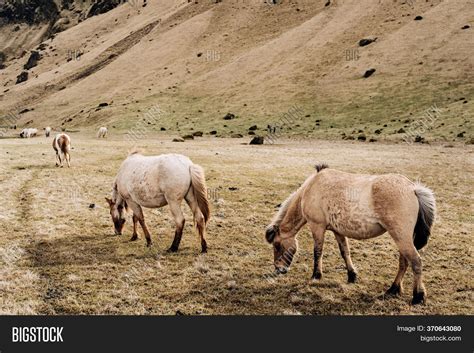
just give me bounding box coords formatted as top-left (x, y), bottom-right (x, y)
top-left (0, 0), bottom-right (474, 142)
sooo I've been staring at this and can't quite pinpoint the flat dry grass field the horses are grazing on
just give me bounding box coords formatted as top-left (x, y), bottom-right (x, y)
top-left (0, 131), bottom-right (474, 315)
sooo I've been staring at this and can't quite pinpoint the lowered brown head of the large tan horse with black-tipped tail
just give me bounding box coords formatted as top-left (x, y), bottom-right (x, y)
top-left (265, 225), bottom-right (298, 274)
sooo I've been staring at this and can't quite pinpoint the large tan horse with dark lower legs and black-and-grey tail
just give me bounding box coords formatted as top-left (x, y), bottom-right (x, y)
top-left (266, 165), bottom-right (436, 304)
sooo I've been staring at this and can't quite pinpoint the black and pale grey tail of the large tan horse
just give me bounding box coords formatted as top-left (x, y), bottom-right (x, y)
top-left (413, 183), bottom-right (436, 250)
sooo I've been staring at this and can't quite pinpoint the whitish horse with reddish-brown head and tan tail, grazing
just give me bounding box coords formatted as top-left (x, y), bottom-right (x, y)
top-left (105, 152), bottom-right (210, 253)
